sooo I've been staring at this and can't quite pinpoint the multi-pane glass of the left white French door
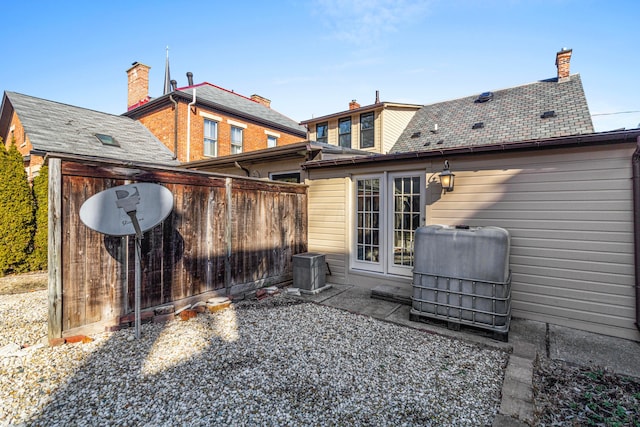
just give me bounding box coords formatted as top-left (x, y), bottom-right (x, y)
top-left (356, 178), bottom-right (381, 263)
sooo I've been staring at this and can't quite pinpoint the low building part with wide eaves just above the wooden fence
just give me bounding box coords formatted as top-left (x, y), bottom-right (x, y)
top-left (182, 141), bottom-right (372, 183)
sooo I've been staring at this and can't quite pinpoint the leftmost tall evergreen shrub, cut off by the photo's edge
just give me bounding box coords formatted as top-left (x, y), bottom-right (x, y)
top-left (0, 141), bottom-right (35, 275)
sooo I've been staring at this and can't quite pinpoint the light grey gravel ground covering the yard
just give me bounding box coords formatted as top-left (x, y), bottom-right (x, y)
top-left (0, 291), bottom-right (508, 426)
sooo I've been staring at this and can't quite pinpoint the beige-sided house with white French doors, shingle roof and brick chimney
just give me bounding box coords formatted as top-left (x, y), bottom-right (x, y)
top-left (303, 50), bottom-right (640, 341)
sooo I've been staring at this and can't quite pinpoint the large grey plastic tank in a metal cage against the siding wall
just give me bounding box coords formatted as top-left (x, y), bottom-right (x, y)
top-left (410, 225), bottom-right (511, 339)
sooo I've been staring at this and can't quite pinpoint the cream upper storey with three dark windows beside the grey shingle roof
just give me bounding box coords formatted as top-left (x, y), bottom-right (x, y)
top-left (301, 91), bottom-right (421, 154)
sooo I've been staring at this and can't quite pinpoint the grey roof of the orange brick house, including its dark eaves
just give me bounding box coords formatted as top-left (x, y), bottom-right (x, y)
top-left (123, 82), bottom-right (307, 138)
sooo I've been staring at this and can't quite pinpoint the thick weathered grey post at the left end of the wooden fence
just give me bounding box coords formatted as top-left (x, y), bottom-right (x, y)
top-left (47, 159), bottom-right (62, 342)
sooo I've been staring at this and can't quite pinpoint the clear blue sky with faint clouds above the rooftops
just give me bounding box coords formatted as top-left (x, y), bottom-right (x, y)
top-left (0, 0), bottom-right (640, 131)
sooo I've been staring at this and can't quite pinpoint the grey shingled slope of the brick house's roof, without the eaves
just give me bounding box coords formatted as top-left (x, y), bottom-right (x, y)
top-left (175, 83), bottom-right (307, 135)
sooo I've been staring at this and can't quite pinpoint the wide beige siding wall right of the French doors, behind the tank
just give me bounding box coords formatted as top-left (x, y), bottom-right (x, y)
top-left (427, 145), bottom-right (640, 340)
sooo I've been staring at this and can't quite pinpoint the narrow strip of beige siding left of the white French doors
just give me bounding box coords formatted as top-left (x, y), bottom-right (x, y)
top-left (306, 178), bottom-right (348, 283)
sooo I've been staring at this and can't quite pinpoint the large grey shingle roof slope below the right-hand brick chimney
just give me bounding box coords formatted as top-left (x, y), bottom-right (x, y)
top-left (390, 74), bottom-right (594, 153)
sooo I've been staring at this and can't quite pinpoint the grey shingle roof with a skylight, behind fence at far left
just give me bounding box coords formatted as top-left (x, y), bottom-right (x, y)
top-left (0, 92), bottom-right (178, 164)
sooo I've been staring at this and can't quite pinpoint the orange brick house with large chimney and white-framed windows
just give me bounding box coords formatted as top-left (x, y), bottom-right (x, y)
top-left (123, 62), bottom-right (306, 162)
